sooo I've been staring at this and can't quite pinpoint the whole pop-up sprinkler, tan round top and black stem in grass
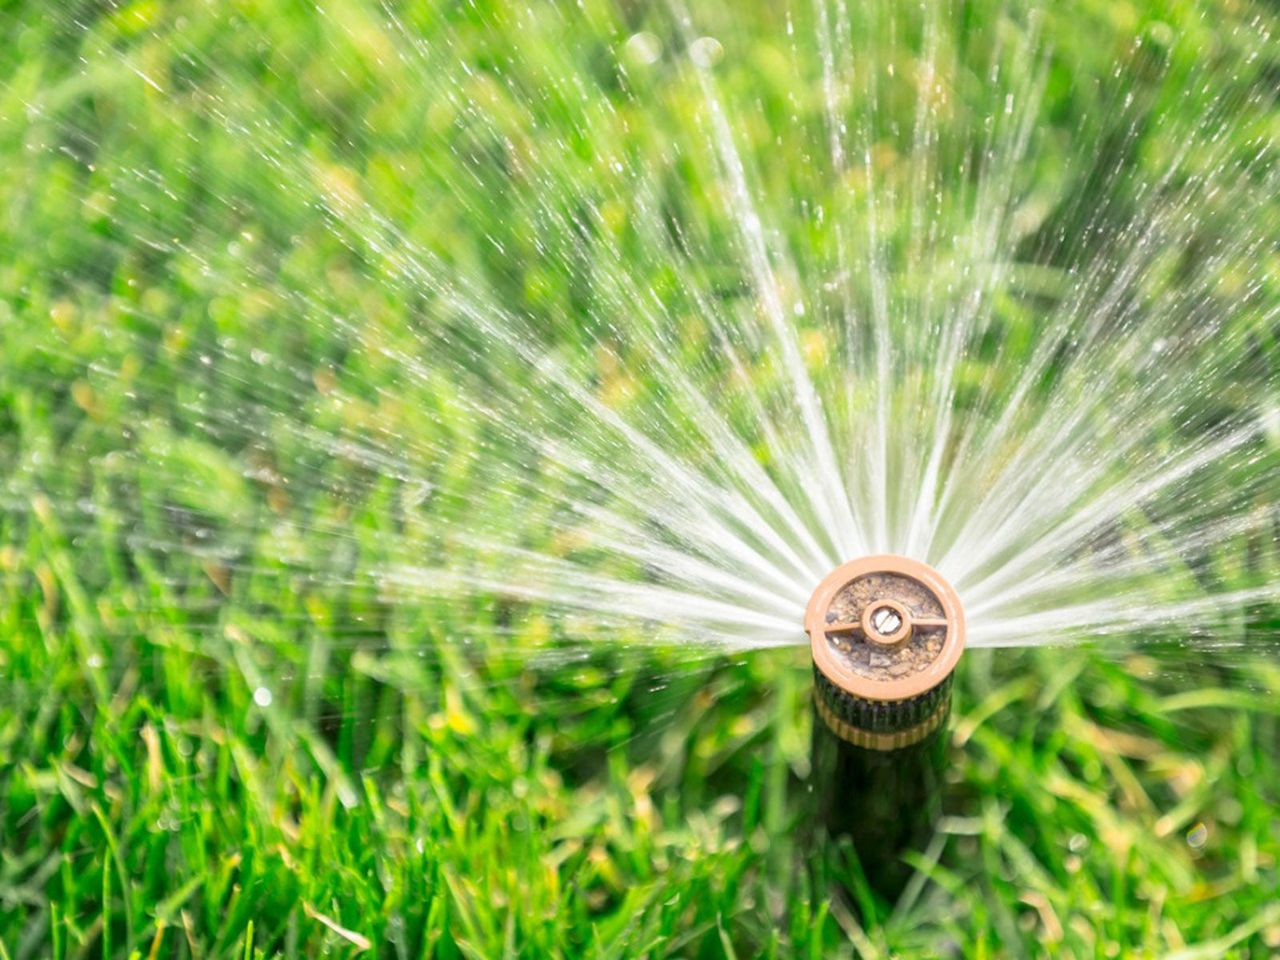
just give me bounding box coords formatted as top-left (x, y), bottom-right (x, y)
top-left (805, 554), bottom-right (964, 896)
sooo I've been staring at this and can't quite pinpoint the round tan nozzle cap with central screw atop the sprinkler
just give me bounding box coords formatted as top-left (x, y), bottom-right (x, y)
top-left (804, 554), bottom-right (964, 701)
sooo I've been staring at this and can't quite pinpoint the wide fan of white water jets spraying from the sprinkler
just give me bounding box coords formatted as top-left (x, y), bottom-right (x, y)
top-left (3, 0), bottom-right (1280, 665)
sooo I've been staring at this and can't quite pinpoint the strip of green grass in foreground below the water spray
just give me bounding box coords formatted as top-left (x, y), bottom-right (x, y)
top-left (0, 555), bottom-right (1280, 957)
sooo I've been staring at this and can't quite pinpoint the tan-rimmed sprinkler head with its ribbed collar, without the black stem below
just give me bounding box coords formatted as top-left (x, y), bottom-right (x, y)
top-left (805, 554), bottom-right (964, 750)
